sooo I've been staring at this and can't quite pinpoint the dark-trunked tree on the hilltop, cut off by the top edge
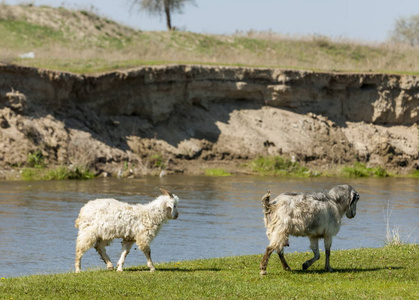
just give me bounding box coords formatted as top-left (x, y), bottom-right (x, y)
top-left (131, 0), bottom-right (195, 30)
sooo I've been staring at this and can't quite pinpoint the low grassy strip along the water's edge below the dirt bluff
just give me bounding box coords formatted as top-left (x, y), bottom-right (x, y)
top-left (0, 156), bottom-right (419, 181)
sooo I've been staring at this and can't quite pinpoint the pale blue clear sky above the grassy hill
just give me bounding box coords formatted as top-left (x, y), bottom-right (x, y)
top-left (3, 0), bottom-right (419, 42)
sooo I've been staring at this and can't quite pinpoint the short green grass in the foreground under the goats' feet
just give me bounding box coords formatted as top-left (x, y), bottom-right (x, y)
top-left (0, 245), bottom-right (419, 299)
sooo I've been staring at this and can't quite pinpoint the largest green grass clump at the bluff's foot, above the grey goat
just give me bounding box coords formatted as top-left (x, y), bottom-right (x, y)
top-left (251, 156), bottom-right (318, 177)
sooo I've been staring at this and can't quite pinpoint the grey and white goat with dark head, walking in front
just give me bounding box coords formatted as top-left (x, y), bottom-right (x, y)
top-left (260, 185), bottom-right (359, 275)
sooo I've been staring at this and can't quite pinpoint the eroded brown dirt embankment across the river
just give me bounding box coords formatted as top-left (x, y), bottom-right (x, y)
top-left (0, 64), bottom-right (419, 175)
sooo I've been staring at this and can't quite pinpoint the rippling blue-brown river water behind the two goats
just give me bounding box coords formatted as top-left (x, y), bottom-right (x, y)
top-left (0, 176), bottom-right (419, 277)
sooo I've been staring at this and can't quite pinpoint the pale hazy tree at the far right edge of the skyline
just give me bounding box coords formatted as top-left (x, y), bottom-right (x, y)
top-left (391, 15), bottom-right (419, 47)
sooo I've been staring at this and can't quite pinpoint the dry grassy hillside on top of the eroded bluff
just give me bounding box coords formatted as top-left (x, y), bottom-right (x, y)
top-left (0, 4), bottom-right (419, 74)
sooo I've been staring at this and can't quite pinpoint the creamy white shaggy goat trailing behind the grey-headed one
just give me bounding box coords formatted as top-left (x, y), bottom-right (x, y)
top-left (75, 189), bottom-right (179, 273)
